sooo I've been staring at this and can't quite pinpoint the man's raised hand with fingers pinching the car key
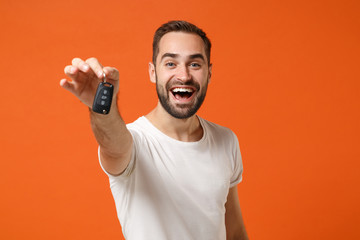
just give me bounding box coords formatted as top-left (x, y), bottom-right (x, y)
top-left (60, 58), bottom-right (119, 108)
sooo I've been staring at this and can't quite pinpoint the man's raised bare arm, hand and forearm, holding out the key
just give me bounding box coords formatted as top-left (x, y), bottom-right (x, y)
top-left (60, 58), bottom-right (133, 175)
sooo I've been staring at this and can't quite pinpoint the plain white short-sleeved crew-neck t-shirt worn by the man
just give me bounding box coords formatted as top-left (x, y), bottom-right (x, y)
top-left (100, 117), bottom-right (242, 240)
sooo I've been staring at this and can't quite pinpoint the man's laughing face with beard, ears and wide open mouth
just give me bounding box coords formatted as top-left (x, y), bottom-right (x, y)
top-left (150, 32), bottom-right (211, 119)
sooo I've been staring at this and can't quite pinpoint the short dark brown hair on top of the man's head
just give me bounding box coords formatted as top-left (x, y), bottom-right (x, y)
top-left (152, 21), bottom-right (211, 65)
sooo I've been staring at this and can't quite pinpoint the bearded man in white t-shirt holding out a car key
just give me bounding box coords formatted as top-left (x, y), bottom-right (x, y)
top-left (60, 21), bottom-right (248, 240)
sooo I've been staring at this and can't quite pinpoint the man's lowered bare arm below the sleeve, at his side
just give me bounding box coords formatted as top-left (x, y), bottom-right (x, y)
top-left (225, 186), bottom-right (249, 240)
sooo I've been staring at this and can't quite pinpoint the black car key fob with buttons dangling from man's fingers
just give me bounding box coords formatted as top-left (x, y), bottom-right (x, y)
top-left (92, 73), bottom-right (114, 114)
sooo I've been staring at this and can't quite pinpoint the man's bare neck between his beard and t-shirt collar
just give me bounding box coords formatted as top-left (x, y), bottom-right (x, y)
top-left (145, 103), bottom-right (203, 142)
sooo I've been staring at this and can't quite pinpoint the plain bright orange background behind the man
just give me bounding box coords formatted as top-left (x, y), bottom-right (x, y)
top-left (0, 0), bottom-right (360, 240)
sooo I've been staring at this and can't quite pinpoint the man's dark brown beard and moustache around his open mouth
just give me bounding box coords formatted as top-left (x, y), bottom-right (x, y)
top-left (156, 76), bottom-right (208, 119)
